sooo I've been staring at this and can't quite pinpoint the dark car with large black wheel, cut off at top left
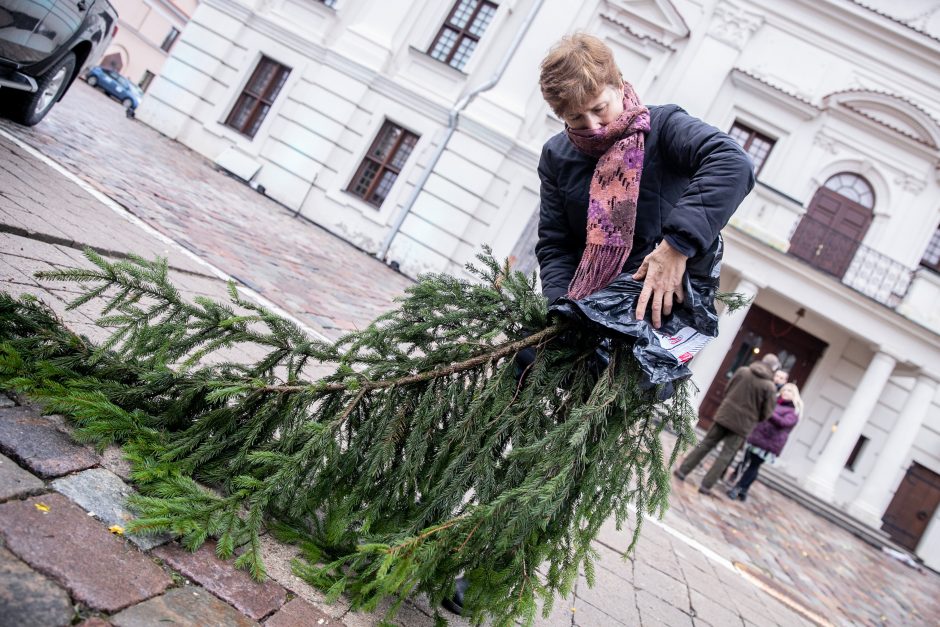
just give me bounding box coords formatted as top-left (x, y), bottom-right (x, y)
top-left (0, 0), bottom-right (117, 126)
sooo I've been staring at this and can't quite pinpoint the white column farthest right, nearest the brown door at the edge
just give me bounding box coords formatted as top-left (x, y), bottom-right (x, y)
top-left (849, 375), bottom-right (937, 528)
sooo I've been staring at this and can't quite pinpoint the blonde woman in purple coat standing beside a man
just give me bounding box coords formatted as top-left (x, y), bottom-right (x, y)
top-left (728, 383), bottom-right (803, 501)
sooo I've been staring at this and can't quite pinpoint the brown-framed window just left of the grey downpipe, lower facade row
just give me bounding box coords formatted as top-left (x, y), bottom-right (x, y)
top-left (347, 120), bottom-right (418, 207)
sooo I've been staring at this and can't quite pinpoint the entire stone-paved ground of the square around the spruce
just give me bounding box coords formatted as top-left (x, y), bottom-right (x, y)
top-left (0, 85), bottom-right (940, 627)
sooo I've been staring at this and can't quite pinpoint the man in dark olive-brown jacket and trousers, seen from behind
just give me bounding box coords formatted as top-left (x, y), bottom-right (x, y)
top-left (673, 353), bottom-right (780, 494)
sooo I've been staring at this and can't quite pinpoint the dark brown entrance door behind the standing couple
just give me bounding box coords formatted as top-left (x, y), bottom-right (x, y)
top-left (698, 305), bottom-right (828, 429)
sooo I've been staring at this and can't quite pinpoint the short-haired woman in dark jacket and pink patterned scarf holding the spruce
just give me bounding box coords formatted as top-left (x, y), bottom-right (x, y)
top-left (535, 34), bottom-right (754, 328)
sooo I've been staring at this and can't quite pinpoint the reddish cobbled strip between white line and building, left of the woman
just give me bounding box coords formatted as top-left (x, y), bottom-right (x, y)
top-left (0, 82), bottom-right (411, 338)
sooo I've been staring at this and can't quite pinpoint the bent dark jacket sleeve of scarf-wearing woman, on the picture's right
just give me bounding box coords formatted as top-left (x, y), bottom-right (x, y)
top-left (660, 109), bottom-right (755, 257)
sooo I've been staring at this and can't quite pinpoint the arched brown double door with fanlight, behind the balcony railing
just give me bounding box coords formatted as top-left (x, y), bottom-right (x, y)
top-left (789, 172), bottom-right (875, 279)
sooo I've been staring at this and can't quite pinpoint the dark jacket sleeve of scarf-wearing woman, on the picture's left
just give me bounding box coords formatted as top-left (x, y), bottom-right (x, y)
top-left (535, 146), bottom-right (578, 304)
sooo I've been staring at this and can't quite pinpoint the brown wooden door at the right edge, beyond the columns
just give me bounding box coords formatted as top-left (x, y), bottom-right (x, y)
top-left (881, 462), bottom-right (940, 551)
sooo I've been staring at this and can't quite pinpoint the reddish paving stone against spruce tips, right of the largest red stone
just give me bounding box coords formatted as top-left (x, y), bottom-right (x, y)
top-left (153, 542), bottom-right (287, 620)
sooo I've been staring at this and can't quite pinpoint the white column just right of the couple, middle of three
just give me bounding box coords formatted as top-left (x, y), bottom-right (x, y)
top-left (805, 352), bottom-right (897, 501)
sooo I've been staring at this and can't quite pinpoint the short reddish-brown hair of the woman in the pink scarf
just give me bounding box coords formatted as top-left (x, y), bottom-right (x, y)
top-left (539, 33), bottom-right (623, 117)
